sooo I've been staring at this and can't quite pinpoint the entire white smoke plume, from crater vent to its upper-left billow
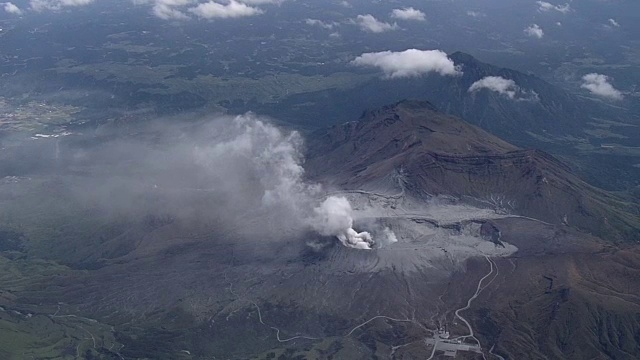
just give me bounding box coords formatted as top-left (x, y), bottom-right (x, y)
top-left (196, 114), bottom-right (384, 249)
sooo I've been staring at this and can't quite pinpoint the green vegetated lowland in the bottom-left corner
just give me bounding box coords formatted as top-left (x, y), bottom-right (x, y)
top-left (0, 252), bottom-right (122, 360)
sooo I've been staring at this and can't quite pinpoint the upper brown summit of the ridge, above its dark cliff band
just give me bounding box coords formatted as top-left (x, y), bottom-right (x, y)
top-left (308, 100), bottom-right (518, 172)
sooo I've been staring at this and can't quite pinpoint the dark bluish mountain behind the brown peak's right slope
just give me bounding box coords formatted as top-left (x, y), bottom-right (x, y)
top-left (398, 52), bottom-right (640, 189)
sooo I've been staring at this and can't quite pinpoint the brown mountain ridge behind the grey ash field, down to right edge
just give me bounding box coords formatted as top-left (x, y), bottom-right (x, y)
top-left (308, 101), bottom-right (640, 240)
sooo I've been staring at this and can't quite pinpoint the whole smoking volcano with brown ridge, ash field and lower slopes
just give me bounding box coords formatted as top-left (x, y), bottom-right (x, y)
top-left (0, 101), bottom-right (640, 359)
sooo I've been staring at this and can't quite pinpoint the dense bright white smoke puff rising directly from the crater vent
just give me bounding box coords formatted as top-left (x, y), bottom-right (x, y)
top-left (311, 196), bottom-right (374, 249)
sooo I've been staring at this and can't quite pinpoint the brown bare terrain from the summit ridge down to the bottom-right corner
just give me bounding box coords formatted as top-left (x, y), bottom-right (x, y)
top-left (308, 101), bottom-right (640, 359)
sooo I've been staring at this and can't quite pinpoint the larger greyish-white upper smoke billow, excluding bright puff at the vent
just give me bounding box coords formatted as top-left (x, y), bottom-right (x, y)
top-left (195, 114), bottom-right (319, 216)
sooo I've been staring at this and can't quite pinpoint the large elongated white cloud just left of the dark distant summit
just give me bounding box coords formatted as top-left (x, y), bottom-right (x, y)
top-left (351, 49), bottom-right (461, 78)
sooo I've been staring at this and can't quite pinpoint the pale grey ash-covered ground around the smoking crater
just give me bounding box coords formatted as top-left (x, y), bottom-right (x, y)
top-left (309, 191), bottom-right (518, 272)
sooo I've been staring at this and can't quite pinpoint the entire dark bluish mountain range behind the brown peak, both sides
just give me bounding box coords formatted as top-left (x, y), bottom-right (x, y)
top-left (262, 52), bottom-right (640, 190)
